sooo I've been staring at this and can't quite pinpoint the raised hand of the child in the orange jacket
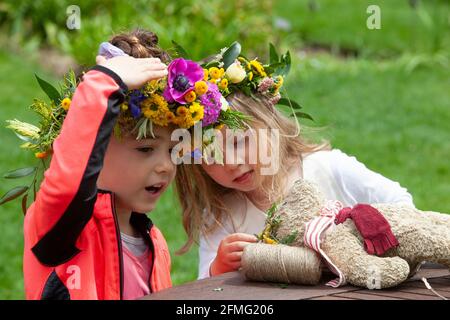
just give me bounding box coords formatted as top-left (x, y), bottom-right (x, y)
top-left (96, 56), bottom-right (167, 89)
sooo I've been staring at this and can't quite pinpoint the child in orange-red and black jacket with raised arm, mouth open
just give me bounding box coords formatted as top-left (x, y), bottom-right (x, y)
top-left (24, 30), bottom-right (176, 299)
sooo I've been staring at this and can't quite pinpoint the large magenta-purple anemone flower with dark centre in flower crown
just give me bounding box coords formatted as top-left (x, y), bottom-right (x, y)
top-left (163, 58), bottom-right (203, 104)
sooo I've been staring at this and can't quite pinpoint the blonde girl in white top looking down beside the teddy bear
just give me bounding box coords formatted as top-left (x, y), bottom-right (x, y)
top-left (176, 46), bottom-right (413, 278)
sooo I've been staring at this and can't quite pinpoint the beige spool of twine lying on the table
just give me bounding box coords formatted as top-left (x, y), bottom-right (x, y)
top-left (242, 243), bottom-right (322, 285)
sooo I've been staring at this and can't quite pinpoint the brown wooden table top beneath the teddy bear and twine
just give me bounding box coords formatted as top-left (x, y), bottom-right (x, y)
top-left (144, 264), bottom-right (450, 300)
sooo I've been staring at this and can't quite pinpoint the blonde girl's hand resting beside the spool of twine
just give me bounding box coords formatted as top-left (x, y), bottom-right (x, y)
top-left (210, 233), bottom-right (258, 276)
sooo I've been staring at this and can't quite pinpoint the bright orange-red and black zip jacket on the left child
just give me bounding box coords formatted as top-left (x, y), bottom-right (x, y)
top-left (23, 66), bottom-right (172, 299)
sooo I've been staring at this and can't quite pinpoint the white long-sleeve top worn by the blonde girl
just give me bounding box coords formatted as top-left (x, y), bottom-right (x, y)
top-left (198, 149), bottom-right (414, 279)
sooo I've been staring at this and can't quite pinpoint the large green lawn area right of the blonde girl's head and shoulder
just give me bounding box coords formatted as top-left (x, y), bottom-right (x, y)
top-left (288, 56), bottom-right (450, 212)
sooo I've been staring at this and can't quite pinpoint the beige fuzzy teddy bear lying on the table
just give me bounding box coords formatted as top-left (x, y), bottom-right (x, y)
top-left (243, 179), bottom-right (450, 289)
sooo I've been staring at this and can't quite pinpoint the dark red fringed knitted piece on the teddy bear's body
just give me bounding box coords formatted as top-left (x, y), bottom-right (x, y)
top-left (335, 204), bottom-right (398, 255)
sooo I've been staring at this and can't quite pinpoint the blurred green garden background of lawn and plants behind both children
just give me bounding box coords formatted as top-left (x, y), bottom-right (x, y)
top-left (0, 0), bottom-right (450, 299)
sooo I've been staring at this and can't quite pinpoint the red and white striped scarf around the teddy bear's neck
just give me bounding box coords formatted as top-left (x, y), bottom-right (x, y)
top-left (303, 200), bottom-right (346, 288)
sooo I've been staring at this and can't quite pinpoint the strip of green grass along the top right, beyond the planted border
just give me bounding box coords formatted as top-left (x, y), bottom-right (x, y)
top-left (274, 0), bottom-right (450, 57)
